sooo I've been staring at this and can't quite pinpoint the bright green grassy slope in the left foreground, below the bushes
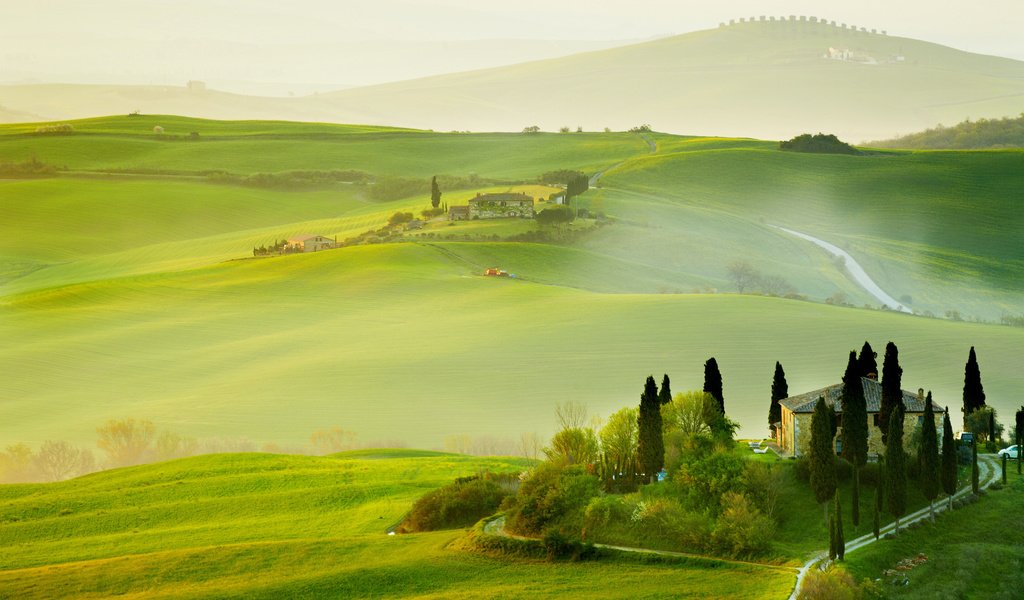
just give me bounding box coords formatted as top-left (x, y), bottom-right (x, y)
top-left (0, 453), bottom-right (793, 598)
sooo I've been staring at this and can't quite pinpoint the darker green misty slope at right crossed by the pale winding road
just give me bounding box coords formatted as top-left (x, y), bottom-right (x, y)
top-left (597, 140), bottom-right (1024, 319)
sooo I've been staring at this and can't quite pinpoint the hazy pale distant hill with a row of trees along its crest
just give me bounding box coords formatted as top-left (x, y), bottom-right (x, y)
top-left (0, 20), bottom-right (1024, 142)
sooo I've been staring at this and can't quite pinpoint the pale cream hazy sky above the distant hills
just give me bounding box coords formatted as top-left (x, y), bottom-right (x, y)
top-left (0, 0), bottom-right (1024, 93)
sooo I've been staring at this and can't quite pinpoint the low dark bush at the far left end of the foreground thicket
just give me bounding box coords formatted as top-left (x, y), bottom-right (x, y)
top-left (398, 473), bottom-right (518, 532)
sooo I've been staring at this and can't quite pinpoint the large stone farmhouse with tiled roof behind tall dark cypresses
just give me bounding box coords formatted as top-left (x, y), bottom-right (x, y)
top-left (775, 377), bottom-right (945, 457)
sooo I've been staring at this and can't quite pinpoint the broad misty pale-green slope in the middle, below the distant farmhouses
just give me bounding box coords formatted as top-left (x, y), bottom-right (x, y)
top-left (0, 243), bottom-right (1024, 446)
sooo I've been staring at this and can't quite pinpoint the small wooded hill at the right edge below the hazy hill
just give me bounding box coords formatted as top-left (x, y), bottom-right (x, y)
top-left (868, 114), bottom-right (1024, 149)
